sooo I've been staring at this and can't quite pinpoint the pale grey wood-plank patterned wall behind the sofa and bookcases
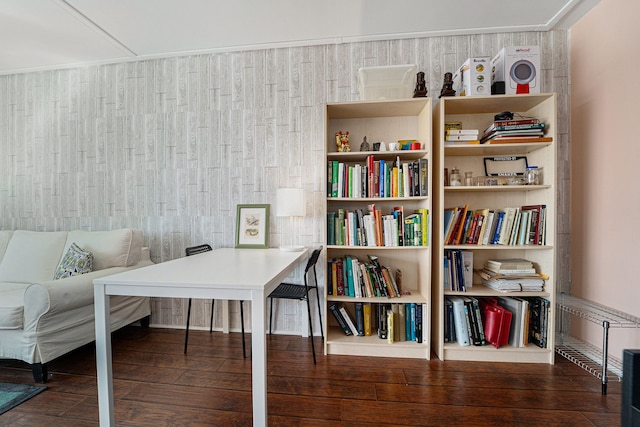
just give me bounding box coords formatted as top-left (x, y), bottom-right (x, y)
top-left (0, 31), bottom-right (569, 333)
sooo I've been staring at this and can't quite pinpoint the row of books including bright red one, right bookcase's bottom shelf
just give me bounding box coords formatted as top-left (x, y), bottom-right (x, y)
top-left (444, 295), bottom-right (550, 348)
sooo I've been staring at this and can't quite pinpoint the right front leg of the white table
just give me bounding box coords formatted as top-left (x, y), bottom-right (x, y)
top-left (251, 291), bottom-right (267, 426)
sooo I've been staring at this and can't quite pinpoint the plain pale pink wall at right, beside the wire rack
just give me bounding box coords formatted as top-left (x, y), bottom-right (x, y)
top-left (570, 0), bottom-right (640, 358)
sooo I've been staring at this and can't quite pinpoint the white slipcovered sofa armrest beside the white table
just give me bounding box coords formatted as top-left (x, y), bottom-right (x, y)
top-left (24, 262), bottom-right (152, 330)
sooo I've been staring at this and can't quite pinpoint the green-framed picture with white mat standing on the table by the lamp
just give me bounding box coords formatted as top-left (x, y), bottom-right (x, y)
top-left (236, 204), bottom-right (269, 249)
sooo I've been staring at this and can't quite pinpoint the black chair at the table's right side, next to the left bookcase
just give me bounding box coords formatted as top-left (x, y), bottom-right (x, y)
top-left (268, 246), bottom-right (324, 364)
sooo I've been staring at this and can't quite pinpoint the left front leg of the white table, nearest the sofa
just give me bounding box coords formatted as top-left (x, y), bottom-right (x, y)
top-left (94, 285), bottom-right (115, 427)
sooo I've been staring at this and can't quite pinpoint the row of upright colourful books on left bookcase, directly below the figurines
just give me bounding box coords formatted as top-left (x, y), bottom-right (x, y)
top-left (327, 155), bottom-right (429, 198)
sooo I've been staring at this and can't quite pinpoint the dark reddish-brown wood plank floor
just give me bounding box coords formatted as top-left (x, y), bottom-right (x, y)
top-left (0, 327), bottom-right (621, 427)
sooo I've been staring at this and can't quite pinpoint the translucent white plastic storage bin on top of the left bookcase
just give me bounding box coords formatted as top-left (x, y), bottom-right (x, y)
top-left (358, 64), bottom-right (418, 101)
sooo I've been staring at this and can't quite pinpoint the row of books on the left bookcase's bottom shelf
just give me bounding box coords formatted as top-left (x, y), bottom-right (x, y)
top-left (329, 302), bottom-right (427, 343)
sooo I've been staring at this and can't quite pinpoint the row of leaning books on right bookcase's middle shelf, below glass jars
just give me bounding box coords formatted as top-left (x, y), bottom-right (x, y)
top-left (444, 204), bottom-right (547, 245)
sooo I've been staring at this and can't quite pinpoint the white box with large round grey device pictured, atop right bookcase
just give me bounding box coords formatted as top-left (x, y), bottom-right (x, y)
top-left (491, 46), bottom-right (540, 94)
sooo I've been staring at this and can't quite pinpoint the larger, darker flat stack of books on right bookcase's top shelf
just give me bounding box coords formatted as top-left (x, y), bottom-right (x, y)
top-left (480, 118), bottom-right (552, 144)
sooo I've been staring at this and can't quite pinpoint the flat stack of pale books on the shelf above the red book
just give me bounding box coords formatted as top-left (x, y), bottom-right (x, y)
top-left (477, 258), bottom-right (544, 292)
